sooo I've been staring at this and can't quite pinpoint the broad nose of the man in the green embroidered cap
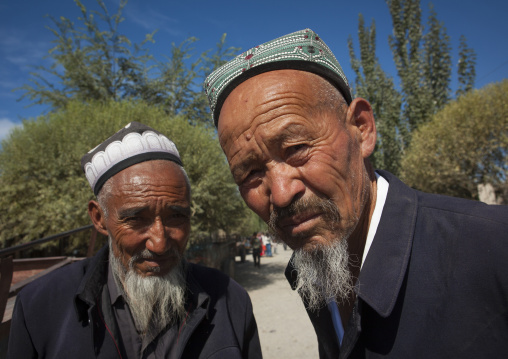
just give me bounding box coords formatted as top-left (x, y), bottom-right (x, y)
top-left (268, 163), bottom-right (305, 208)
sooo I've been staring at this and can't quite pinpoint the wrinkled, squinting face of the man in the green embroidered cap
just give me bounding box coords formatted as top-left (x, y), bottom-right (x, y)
top-left (218, 70), bottom-right (375, 249)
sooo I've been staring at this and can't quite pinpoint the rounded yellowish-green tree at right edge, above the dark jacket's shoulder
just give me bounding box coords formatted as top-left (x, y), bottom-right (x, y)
top-left (402, 80), bottom-right (508, 200)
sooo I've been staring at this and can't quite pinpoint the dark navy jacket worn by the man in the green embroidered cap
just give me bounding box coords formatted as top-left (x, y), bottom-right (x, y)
top-left (286, 171), bottom-right (508, 359)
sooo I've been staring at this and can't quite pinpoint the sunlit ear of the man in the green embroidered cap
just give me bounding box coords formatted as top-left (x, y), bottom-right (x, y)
top-left (347, 97), bottom-right (377, 158)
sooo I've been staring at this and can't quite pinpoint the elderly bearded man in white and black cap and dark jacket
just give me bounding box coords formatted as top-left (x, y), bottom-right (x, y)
top-left (8, 122), bottom-right (261, 359)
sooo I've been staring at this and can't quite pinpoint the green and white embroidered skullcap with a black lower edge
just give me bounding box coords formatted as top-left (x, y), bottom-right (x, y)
top-left (204, 29), bottom-right (352, 126)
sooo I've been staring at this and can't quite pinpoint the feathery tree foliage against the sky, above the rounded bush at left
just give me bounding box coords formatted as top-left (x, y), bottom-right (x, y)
top-left (16, 0), bottom-right (238, 123)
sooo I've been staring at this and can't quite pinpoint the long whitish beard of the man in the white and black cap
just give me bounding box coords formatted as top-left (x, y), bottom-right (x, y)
top-left (109, 239), bottom-right (186, 337)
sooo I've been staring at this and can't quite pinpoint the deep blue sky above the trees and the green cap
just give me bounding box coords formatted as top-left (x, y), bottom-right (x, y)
top-left (0, 0), bottom-right (508, 139)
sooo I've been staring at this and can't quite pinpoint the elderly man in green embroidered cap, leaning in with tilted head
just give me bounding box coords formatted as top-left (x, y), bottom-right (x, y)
top-left (204, 29), bottom-right (508, 358)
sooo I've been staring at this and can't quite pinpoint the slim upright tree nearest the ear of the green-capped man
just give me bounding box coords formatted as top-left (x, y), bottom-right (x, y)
top-left (348, 14), bottom-right (406, 174)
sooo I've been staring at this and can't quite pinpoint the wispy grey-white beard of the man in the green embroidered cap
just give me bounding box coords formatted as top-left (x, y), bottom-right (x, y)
top-left (292, 239), bottom-right (354, 311)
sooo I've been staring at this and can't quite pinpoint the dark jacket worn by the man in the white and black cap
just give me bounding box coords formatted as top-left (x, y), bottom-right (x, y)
top-left (7, 247), bottom-right (262, 359)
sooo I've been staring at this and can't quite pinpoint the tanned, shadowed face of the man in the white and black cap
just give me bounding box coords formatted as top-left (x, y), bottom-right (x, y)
top-left (95, 160), bottom-right (190, 276)
